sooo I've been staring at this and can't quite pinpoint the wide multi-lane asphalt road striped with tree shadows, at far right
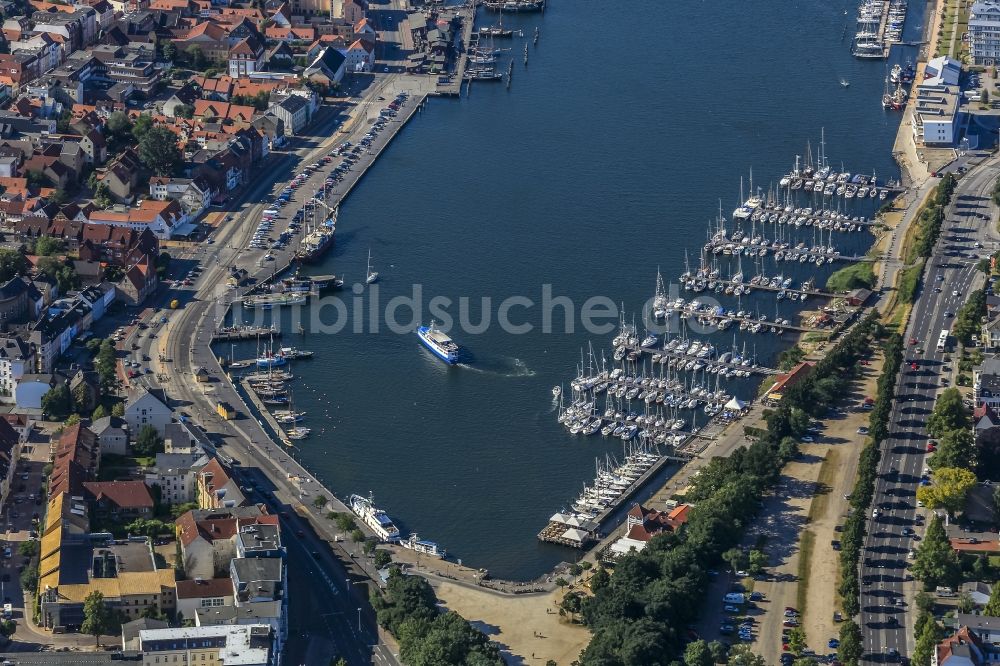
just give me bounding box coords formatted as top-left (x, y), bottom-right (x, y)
top-left (861, 154), bottom-right (1000, 663)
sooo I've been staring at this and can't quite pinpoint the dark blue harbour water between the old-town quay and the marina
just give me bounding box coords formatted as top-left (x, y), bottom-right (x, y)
top-left (227, 0), bottom-right (923, 577)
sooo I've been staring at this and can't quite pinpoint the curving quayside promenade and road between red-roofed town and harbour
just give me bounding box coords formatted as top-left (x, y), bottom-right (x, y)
top-left (127, 68), bottom-right (450, 666)
